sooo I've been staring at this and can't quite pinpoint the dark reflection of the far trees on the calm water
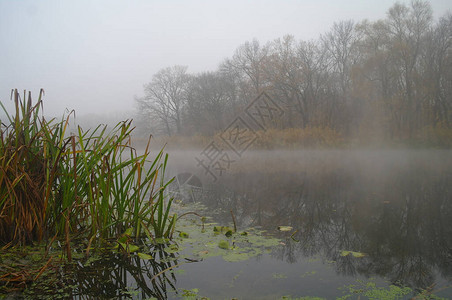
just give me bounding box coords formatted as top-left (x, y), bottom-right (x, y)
top-left (192, 152), bottom-right (452, 289)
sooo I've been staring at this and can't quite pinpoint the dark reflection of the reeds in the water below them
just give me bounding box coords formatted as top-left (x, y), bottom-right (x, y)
top-left (55, 246), bottom-right (178, 299)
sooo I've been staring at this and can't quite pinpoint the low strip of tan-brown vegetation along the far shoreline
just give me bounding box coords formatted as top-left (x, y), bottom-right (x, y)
top-left (139, 124), bottom-right (452, 150)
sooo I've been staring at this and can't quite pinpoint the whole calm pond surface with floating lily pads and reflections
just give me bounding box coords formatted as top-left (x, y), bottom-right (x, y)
top-left (24, 150), bottom-right (452, 299)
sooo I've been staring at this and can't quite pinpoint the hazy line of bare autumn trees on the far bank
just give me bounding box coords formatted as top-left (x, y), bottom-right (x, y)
top-left (136, 1), bottom-right (452, 144)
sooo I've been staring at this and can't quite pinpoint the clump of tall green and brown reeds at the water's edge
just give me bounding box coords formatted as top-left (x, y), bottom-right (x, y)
top-left (0, 90), bottom-right (176, 250)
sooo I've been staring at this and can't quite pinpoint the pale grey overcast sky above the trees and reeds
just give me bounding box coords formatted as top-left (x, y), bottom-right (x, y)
top-left (0, 0), bottom-right (452, 116)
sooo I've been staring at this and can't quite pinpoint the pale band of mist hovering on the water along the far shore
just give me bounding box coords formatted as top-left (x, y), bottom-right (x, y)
top-left (168, 149), bottom-right (452, 180)
